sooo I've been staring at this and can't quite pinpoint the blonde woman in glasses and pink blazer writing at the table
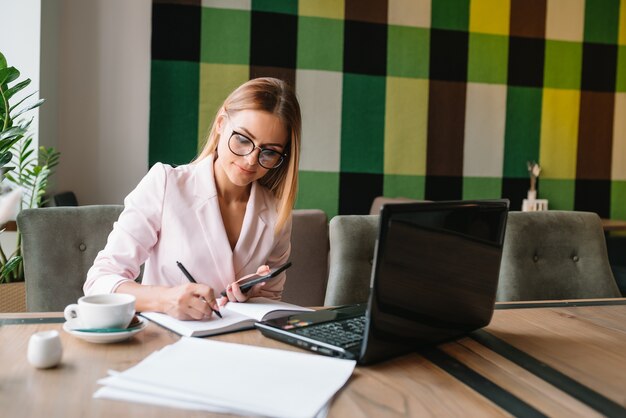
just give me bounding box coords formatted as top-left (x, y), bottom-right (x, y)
top-left (83, 78), bottom-right (301, 319)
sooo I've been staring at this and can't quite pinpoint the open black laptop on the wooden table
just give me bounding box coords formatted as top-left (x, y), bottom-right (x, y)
top-left (256, 200), bottom-right (509, 364)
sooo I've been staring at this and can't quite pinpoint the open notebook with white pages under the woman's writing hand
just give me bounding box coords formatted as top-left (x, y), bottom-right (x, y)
top-left (141, 298), bottom-right (312, 337)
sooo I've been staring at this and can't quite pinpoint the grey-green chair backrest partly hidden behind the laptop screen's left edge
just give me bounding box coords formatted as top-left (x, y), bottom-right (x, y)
top-left (324, 215), bottom-right (379, 306)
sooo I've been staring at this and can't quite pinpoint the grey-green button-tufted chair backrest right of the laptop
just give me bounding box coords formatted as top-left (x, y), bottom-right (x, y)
top-left (497, 211), bottom-right (620, 301)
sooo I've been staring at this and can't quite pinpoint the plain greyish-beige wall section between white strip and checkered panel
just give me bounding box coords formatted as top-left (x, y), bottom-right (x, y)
top-left (48, 0), bottom-right (152, 205)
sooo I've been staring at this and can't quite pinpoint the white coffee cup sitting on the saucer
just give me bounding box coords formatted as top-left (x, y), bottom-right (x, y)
top-left (63, 293), bottom-right (135, 329)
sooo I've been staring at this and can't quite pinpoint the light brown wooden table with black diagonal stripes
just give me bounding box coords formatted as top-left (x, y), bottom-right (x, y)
top-left (0, 299), bottom-right (626, 417)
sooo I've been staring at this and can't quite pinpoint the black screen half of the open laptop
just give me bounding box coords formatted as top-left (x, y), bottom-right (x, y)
top-left (362, 200), bottom-right (508, 357)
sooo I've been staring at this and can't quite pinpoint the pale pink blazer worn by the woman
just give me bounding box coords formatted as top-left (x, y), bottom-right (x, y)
top-left (83, 156), bottom-right (291, 299)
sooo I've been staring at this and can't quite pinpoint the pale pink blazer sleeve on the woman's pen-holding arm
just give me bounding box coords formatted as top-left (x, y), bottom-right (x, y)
top-left (83, 163), bottom-right (167, 295)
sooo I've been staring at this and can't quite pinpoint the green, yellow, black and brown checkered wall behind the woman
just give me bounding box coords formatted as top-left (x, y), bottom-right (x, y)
top-left (149, 0), bottom-right (626, 219)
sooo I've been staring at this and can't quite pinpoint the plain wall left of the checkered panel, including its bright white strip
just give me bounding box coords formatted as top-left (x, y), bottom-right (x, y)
top-left (0, 0), bottom-right (152, 204)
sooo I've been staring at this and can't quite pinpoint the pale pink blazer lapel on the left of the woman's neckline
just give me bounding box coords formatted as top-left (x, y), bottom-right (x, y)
top-left (194, 156), bottom-right (234, 290)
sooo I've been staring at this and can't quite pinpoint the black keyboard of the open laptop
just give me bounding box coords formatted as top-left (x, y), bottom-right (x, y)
top-left (294, 315), bottom-right (365, 348)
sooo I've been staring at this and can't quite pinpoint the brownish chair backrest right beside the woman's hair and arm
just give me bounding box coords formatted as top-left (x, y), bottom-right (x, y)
top-left (282, 209), bottom-right (329, 306)
